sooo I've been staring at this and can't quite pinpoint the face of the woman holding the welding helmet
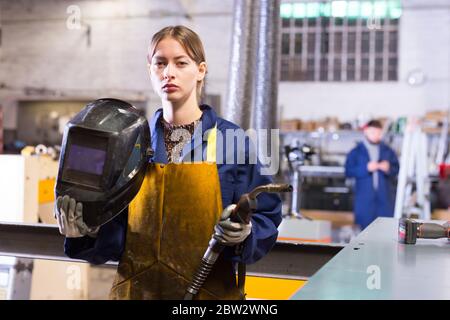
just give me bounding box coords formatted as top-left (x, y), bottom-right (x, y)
top-left (149, 37), bottom-right (206, 102)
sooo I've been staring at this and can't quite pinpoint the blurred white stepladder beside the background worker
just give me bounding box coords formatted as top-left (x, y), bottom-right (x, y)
top-left (394, 118), bottom-right (431, 220)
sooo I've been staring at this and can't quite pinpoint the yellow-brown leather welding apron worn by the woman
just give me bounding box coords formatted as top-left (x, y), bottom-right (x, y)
top-left (110, 128), bottom-right (243, 300)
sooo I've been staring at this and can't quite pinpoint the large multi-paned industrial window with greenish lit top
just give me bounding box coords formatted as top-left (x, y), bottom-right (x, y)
top-left (280, 0), bottom-right (402, 81)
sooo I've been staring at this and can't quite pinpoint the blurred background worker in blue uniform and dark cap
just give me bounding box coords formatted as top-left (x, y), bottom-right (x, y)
top-left (345, 120), bottom-right (399, 229)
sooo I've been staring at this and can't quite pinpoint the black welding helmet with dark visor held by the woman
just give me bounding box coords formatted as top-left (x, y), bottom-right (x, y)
top-left (55, 99), bottom-right (152, 227)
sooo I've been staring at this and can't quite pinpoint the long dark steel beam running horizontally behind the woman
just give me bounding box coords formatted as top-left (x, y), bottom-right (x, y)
top-left (0, 223), bottom-right (343, 278)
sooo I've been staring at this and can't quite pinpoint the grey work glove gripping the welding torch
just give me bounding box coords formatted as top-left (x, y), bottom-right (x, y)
top-left (213, 204), bottom-right (252, 246)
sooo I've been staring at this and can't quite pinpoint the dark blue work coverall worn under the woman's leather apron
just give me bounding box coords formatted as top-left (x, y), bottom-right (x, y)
top-left (64, 105), bottom-right (282, 264)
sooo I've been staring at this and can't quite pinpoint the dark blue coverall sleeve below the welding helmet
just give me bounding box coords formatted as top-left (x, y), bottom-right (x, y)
top-left (64, 209), bottom-right (128, 264)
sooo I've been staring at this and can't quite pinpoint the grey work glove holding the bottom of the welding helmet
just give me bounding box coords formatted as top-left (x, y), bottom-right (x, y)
top-left (54, 195), bottom-right (100, 238)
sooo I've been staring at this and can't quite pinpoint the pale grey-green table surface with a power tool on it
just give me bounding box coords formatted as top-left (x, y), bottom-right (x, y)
top-left (291, 218), bottom-right (450, 300)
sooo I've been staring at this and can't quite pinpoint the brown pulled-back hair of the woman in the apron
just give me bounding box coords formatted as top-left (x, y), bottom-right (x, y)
top-left (147, 25), bottom-right (206, 102)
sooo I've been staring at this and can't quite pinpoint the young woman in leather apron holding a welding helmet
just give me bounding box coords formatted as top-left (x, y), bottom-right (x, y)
top-left (55, 26), bottom-right (281, 299)
